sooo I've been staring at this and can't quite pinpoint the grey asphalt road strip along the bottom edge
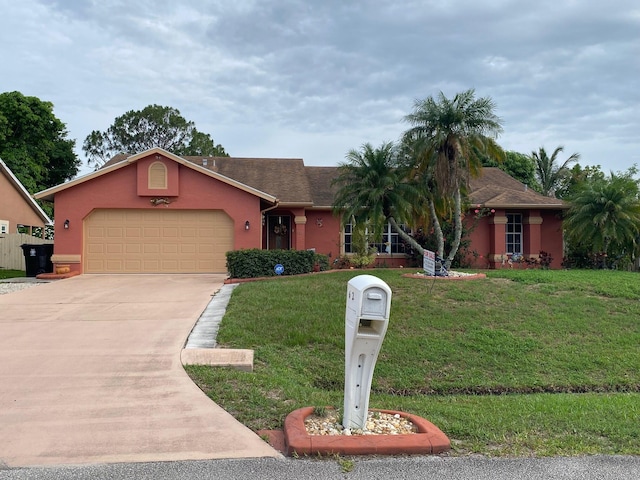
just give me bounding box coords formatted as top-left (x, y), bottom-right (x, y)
top-left (0, 456), bottom-right (640, 480)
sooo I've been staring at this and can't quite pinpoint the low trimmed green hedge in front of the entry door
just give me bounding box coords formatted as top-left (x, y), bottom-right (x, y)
top-left (227, 248), bottom-right (329, 278)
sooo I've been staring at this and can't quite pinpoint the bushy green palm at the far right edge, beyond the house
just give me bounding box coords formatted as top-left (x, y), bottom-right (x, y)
top-left (564, 172), bottom-right (640, 259)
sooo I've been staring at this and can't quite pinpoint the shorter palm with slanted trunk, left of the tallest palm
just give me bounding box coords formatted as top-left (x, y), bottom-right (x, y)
top-left (333, 142), bottom-right (423, 252)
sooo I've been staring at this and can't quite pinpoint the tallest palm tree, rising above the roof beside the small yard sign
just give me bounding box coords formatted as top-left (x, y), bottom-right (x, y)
top-left (403, 89), bottom-right (504, 268)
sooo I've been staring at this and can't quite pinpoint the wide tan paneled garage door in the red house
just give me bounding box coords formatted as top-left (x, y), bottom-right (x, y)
top-left (84, 209), bottom-right (233, 273)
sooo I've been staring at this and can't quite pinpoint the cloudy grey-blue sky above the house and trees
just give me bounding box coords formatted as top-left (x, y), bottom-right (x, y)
top-left (0, 0), bottom-right (640, 173)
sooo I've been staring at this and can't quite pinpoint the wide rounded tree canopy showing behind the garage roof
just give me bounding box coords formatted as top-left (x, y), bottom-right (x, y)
top-left (82, 105), bottom-right (229, 169)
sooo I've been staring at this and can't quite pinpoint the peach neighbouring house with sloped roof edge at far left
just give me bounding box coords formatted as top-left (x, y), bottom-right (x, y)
top-left (0, 160), bottom-right (51, 236)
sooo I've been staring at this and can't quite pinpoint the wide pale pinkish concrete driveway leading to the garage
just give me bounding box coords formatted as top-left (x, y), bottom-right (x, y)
top-left (0, 275), bottom-right (279, 467)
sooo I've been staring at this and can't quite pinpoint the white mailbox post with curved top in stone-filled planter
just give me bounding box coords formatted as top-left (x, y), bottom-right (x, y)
top-left (342, 275), bottom-right (391, 430)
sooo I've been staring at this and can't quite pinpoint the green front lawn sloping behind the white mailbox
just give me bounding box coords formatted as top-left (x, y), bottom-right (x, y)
top-left (187, 269), bottom-right (640, 455)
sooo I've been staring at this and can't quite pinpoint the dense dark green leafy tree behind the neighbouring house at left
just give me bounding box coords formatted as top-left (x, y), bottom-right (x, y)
top-left (0, 92), bottom-right (81, 193)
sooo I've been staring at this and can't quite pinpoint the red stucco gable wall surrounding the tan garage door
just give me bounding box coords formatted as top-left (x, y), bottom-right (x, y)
top-left (53, 159), bottom-right (261, 272)
